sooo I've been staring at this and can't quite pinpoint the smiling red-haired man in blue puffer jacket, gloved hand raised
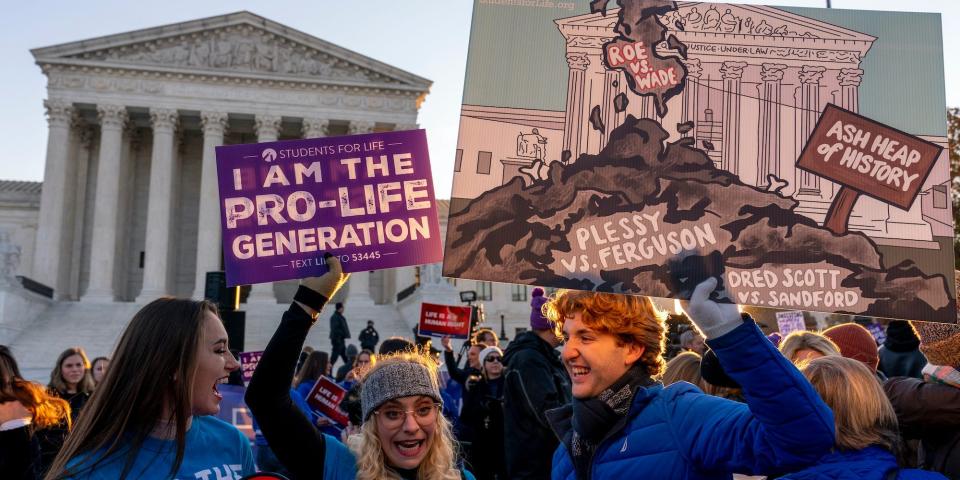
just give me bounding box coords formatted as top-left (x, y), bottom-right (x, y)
top-left (545, 278), bottom-right (834, 480)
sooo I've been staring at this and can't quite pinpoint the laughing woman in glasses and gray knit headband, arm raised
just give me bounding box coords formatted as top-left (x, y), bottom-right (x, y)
top-left (246, 254), bottom-right (474, 480)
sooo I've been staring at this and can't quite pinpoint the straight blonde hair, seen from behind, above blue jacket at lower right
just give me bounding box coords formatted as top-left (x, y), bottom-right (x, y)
top-left (800, 356), bottom-right (900, 453)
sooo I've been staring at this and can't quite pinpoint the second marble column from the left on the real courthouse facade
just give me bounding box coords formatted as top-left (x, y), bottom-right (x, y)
top-left (81, 105), bottom-right (127, 302)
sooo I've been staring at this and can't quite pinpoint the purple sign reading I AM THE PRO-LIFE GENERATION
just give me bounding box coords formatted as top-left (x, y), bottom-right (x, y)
top-left (217, 130), bottom-right (443, 286)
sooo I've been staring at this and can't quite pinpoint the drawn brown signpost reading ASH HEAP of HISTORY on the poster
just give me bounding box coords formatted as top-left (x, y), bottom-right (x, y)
top-left (797, 104), bottom-right (943, 235)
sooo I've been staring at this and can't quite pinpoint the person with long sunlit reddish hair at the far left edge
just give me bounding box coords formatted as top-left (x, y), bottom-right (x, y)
top-left (0, 345), bottom-right (70, 480)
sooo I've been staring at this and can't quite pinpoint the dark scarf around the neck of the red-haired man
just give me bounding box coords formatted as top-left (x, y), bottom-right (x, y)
top-left (570, 363), bottom-right (654, 479)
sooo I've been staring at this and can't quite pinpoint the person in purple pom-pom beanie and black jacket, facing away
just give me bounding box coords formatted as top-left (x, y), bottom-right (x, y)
top-left (503, 287), bottom-right (571, 480)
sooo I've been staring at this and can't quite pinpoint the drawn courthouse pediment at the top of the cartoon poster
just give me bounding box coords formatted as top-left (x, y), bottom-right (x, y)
top-left (556, 2), bottom-right (876, 47)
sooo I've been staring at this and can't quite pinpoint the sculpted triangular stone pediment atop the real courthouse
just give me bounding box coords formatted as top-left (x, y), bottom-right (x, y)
top-left (31, 12), bottom-right (431, 92)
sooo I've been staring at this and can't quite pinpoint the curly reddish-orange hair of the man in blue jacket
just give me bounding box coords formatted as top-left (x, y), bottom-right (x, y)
top-left (543, 289), bottom-right (666, 377)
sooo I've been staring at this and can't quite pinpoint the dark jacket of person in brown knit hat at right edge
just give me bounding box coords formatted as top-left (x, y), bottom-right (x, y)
top-left (883, 377), bottom-right (960, 480)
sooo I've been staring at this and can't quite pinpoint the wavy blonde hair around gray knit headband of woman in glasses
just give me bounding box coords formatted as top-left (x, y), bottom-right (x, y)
top-left (348, 350), bottom-right (460, 480)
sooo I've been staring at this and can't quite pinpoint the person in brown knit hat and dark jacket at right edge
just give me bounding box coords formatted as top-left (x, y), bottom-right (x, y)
top-left (883, 322), bottom-right (960, 479)
